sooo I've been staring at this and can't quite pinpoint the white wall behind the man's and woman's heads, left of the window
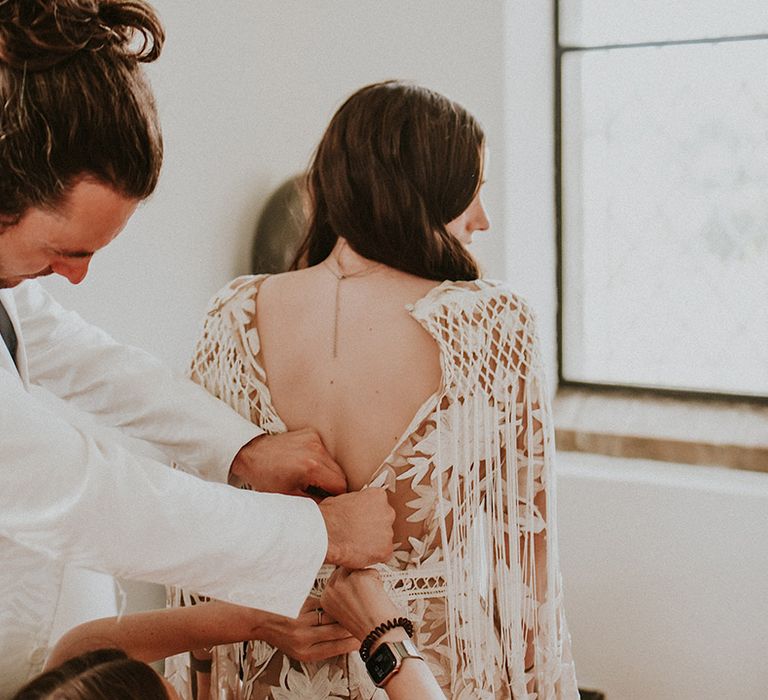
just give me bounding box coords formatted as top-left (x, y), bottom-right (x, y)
top-left (50, 0), bottom-right (554, 368)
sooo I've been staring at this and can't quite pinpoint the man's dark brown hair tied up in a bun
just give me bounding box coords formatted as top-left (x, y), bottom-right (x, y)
top-left (0, 0), bottom-right (165, 223)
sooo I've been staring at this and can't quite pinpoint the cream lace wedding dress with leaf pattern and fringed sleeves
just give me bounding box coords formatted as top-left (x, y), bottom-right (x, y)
top-left (167, 275), bottom-right (578, 700)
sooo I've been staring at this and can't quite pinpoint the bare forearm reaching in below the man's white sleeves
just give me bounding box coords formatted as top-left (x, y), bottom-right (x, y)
top-left (46, 601), bottom-right (268, 668)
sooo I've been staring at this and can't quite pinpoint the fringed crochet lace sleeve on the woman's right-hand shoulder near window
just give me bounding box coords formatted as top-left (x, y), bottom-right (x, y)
top-left (424, 287), bottom-right (578, 698)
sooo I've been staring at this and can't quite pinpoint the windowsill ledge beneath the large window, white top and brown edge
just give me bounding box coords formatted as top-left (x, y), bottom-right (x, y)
top-left (553, 387), bottom-right (768, 472)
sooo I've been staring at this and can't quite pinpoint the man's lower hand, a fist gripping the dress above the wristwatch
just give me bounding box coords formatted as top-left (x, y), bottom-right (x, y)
top-left (320, 488), bottom-right (395, 569)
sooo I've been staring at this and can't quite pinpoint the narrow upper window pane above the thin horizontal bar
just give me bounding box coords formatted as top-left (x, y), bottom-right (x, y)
top-left (559, 0), bottom-right (768, 46)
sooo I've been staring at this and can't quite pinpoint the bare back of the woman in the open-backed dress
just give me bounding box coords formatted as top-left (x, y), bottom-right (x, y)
top-left (256, 258), bottom-right (441, 490)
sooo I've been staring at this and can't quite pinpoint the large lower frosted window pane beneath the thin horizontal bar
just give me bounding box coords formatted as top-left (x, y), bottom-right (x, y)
top-left (562, 41), bottom-right (768, 396)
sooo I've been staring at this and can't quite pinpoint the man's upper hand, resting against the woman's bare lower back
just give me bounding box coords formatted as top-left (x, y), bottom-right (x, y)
top-left (230, 428), bottom-right (347, 497)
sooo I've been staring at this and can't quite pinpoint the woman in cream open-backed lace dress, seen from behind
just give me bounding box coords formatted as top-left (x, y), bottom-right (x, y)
top-left (170, 81), bottom-right (578, 700)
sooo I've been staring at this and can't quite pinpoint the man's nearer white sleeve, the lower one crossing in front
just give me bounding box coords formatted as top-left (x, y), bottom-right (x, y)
top-left (0, 369), bottom-right (327, 616)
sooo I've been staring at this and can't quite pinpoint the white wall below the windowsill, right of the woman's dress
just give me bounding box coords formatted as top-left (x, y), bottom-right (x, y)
top-left (558, 454), bottom-right (768, 700)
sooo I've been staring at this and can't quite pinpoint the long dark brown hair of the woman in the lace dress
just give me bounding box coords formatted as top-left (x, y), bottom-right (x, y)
top-left (293, 81), bottom-right (485, 280)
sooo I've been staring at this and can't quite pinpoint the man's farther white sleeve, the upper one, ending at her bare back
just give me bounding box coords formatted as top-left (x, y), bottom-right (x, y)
top-left (14, 282), bottom-right (263, 482)
